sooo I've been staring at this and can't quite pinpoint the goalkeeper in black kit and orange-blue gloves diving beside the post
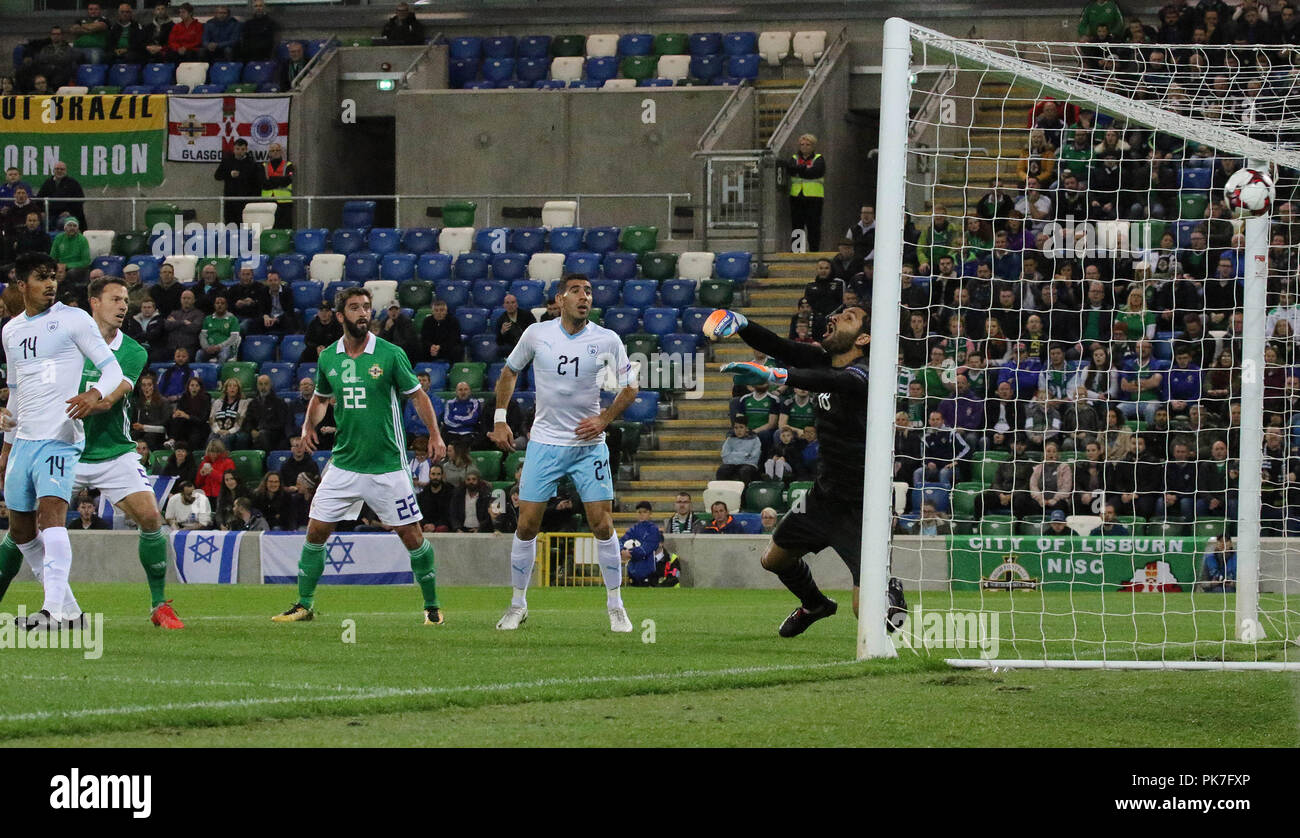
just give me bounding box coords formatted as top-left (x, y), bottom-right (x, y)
top-left (703, 305), bottom-right (907, 637)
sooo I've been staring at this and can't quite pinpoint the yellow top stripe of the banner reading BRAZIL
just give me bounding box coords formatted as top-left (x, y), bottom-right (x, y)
top-left (0, 94), bottom-right (166, 134)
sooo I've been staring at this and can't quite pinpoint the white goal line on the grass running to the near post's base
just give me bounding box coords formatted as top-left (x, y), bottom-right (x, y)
top-left (0, 660), bottom-right (873, 724)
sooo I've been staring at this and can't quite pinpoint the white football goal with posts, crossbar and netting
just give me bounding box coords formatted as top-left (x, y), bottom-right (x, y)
top-left (859, 19), bottom-right (1300, 668)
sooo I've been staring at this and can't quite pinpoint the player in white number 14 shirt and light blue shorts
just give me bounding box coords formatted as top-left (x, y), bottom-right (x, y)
top-left (0, 253), bottom-right (124, 629)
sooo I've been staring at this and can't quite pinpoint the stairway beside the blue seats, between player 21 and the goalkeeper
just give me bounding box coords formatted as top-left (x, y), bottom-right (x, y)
top-left (614, 253), bottom-right (833, 522)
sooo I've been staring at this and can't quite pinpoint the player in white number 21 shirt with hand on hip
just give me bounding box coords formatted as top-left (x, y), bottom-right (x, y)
top-left (490, 274), bottom-right (637, 631)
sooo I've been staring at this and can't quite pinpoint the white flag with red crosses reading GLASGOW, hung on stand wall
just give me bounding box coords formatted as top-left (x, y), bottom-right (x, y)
top-left (166, 96), bottom-right (289, 162)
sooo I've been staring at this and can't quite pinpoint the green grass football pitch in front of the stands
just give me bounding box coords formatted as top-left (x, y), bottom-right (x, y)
top-left (0, 583), bottom-right (1300, 747)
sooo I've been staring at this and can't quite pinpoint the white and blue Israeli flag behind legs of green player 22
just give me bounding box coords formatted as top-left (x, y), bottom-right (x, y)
top-left (260, 533), bottom-right (415, 585)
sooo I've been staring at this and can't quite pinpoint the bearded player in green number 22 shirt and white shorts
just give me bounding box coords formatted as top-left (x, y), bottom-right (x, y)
top-left (272, 287), bottom-right (447, 625)
